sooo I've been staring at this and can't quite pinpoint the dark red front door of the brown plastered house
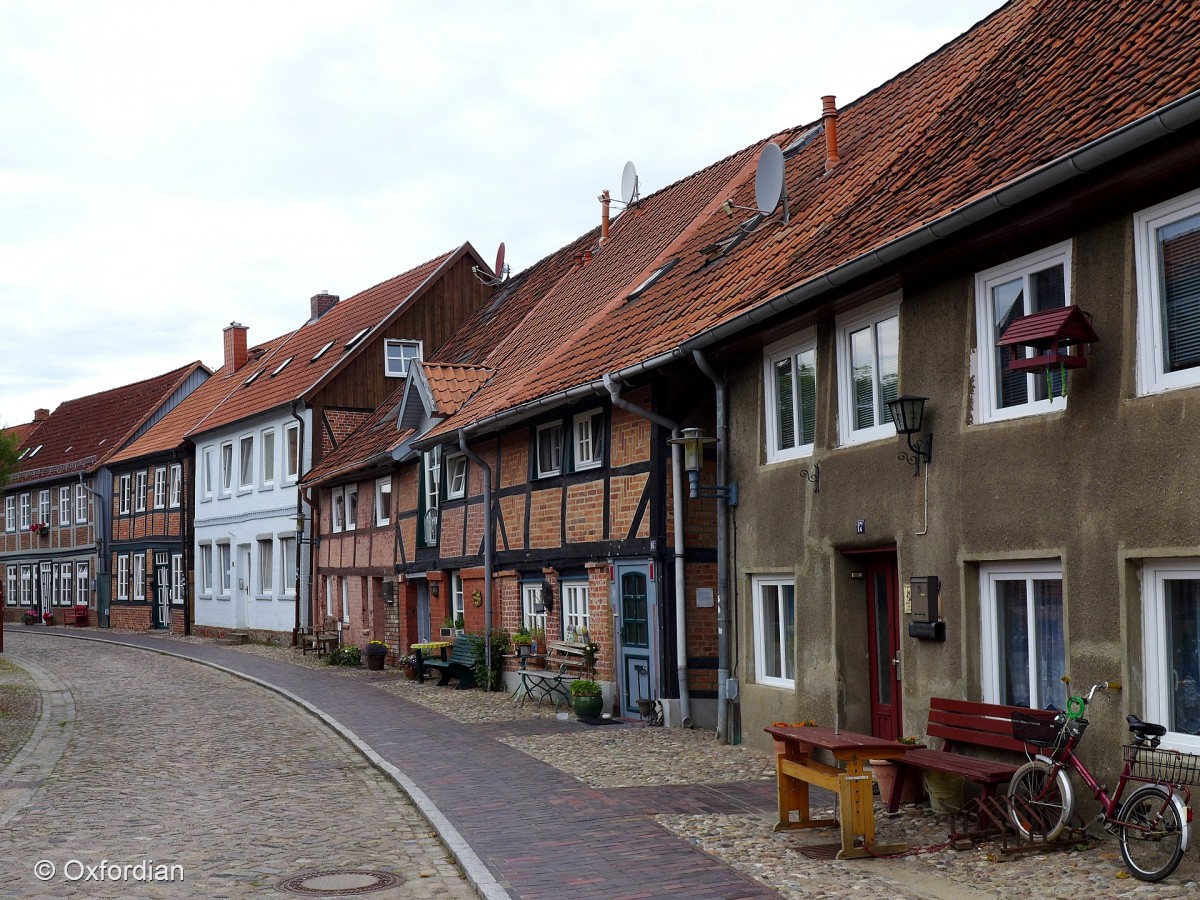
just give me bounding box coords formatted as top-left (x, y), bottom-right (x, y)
top-left (865, 553), bottom-right (901, 740)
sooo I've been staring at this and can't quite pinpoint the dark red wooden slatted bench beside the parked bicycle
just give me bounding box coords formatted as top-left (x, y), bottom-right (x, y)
top-left (881, 697), bottom-right (1055, 812)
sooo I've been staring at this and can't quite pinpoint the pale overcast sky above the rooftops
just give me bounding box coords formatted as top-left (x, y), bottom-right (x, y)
top-left (0, 0), bottom-right (1002, 425)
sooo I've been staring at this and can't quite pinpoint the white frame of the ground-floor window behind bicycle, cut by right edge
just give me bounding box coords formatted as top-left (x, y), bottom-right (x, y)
top-left (1141, 558), bottom-right (1200, 754)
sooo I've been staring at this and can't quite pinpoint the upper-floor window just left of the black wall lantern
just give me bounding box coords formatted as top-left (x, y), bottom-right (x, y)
top-left (838, 296), bottom-right (900, 444)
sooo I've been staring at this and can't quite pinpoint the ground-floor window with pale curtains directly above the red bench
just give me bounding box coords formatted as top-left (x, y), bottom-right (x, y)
top-left (979, 559), bottom-right (1067, 709)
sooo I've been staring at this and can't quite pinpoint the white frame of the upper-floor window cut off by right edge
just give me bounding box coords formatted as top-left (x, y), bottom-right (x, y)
top-left (1133, 191), bottom-right (1200, 396)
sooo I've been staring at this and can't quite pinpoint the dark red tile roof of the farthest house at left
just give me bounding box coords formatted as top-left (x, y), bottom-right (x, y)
top-left (13, 361), bottom-right (204, 485)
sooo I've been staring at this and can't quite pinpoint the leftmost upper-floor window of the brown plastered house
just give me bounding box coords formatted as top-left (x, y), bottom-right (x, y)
top-left (762, 332), bottom-right (817, 462)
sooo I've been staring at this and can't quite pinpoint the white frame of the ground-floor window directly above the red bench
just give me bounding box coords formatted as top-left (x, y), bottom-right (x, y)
top-left (979, 559), bottom-right (1067, 709)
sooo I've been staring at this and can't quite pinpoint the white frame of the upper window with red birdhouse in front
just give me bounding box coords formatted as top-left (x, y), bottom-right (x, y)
top-left (974, 241), bottom-right (1072, 422)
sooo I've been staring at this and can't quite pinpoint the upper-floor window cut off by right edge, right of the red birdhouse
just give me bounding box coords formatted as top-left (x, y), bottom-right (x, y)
top-left (1134, 191), bottom-right (1200, 394)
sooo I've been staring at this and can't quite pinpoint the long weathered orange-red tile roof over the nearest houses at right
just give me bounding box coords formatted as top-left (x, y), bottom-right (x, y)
top-left (424, 0), bottom-right (1200, 433)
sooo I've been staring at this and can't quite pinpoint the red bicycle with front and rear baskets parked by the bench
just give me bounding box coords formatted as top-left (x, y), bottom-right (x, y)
top-left (1008, 678), bottom-right (1200, 881)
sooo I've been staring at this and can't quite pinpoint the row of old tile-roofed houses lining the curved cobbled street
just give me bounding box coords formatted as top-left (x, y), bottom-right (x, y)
top-left (0, 0), bottom-right (1200, 750)
